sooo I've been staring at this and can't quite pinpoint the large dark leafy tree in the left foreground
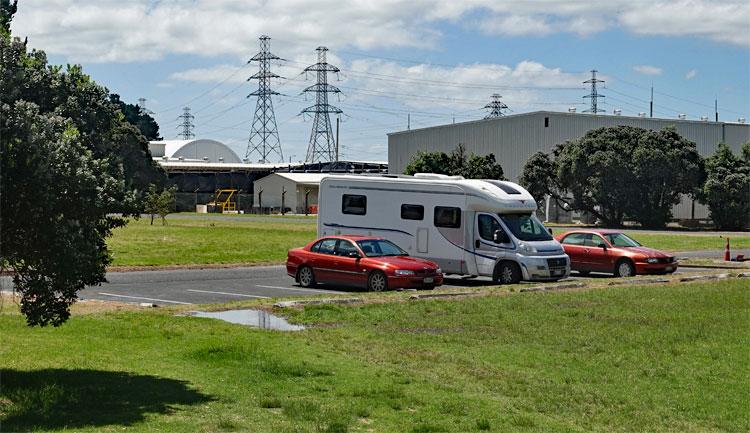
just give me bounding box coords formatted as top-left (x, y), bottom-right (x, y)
top-left (0, 19), bottom-right (165, 326)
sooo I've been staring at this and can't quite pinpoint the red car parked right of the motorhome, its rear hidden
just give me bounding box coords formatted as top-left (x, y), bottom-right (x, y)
top-left (555, 230), bottom-right (677, 277)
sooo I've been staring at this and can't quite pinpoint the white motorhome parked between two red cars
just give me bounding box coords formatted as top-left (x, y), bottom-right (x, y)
top-left (318, 174), bottom-right (570, 283)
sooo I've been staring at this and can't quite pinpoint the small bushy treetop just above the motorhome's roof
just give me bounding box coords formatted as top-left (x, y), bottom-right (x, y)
top-left (404, 144), bottom-right (505, 180)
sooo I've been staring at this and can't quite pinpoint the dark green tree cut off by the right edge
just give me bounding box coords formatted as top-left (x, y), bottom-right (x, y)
top-left (699, 142), bottom-right (750, 230)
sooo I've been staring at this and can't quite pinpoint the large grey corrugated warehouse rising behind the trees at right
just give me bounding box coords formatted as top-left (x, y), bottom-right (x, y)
top-left (388, 111), bottom-right (750, 222)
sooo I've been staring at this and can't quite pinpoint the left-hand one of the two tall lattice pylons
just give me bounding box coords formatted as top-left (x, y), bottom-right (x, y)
top-left (245, 35), bottom-right (284, 162)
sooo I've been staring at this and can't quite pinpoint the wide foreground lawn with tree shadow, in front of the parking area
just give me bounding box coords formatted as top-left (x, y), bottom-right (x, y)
top-left (0, 280), bottom-right (750, 433)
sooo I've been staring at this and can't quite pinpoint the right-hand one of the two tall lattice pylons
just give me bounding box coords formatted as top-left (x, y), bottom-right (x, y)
top-left (302, 47), bottom-right (342, 162)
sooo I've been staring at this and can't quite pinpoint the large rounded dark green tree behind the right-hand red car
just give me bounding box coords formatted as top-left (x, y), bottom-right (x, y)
top-left (520, 126), bottom-right (703, 227)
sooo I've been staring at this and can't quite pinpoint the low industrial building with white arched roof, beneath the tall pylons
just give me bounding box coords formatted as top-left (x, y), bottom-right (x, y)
top-left (149, 139), bottom-right (388, 212)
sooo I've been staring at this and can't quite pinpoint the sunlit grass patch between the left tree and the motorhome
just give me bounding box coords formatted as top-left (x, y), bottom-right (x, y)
top-left (107, 217), bottom-right (316, 266)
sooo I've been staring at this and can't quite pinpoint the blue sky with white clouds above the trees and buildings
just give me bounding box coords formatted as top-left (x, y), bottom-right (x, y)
top-left (11, 0), bottom-right (750, 162)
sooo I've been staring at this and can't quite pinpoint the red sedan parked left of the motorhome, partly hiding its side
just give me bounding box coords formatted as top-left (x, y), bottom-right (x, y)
top-left (286, 236), bottom-right (443, 292)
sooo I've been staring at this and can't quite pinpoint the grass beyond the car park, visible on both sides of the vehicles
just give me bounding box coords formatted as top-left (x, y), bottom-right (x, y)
top-left (107, 214), bottom-right (750, 266)
